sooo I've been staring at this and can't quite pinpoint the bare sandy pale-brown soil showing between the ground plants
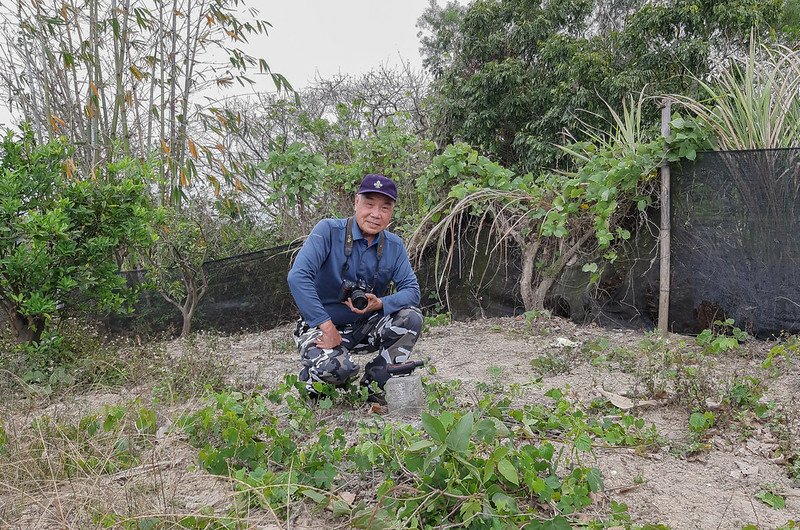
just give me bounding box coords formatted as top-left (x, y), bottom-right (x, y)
top-left (0, 318), bottom-right (800, 530)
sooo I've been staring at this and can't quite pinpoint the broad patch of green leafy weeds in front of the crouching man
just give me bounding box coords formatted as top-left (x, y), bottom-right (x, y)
top-left (180, 374), bottom-right (654, 528)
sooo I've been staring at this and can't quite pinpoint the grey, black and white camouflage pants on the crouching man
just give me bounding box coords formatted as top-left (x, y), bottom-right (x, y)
top-left (294, 307), bottom-right (422, 389)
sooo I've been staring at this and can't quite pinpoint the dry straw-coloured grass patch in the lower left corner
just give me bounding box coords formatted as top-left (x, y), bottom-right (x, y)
top-left (0, 334), bottom-right (281, 529)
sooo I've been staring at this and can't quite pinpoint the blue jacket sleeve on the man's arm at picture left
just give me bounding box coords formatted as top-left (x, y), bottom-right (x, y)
top-left (287, 221), bottom-right (331, 327)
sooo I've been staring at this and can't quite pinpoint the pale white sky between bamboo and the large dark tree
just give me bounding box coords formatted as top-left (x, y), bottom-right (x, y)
top-left (0, 0), bottom-right (443, 124)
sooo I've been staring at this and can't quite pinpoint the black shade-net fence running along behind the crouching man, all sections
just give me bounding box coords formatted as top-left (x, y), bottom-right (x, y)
top-left (103, 149), bottom-right (800, 336)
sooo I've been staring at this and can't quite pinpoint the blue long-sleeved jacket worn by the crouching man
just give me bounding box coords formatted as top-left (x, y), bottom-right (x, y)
top-left (288, 219), bottom-right (420, 327)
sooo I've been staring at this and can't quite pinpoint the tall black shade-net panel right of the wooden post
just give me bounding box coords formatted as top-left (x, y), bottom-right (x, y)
top-left (670, 145), bottom-right (800, 336)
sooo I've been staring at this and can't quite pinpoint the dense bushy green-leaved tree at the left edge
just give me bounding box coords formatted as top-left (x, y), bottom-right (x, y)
top-left (0, 128), bottom-right (152, 343)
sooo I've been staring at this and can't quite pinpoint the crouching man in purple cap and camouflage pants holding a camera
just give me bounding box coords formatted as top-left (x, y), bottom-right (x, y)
top-left (288, 174), bottom-right (422, 402)
